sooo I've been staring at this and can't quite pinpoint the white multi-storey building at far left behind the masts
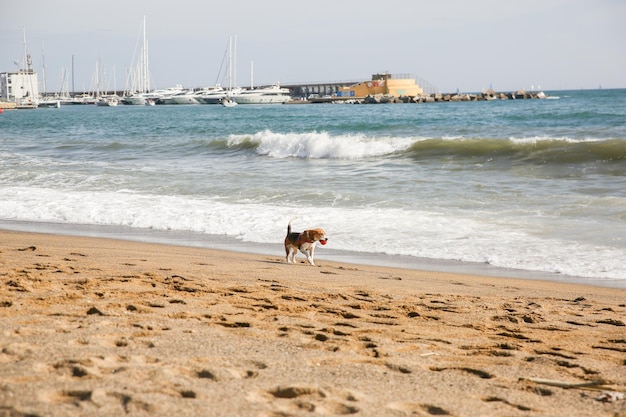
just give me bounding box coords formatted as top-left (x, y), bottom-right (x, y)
top-left (0, 55), bottom-right (39, 107)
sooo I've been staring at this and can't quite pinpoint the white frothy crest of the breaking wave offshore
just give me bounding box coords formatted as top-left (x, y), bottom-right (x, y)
top-left (228, 130), bottom-right (414, 159)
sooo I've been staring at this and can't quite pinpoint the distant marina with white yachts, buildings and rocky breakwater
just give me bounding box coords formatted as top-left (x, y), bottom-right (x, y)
top-left (0, 23), bottom-right (546, 109)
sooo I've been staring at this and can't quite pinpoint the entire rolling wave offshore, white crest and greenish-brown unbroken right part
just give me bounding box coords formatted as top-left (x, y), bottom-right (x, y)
top-left (223, 130), bottom-right (626, 164)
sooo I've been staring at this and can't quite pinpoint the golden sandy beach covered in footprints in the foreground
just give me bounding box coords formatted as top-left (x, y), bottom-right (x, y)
top-left (0, 231), bottom-right (626, 417)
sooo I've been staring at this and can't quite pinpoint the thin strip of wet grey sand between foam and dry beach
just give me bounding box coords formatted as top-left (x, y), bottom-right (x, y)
top-left (0, 220), bottom-right (626, 289)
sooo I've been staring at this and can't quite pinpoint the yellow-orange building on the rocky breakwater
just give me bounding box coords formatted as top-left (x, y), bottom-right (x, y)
top-left (337, 73), bottom-right (424, 98)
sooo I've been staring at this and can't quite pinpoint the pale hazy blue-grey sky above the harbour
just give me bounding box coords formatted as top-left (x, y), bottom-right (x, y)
top-left (0, 0), bottom-right (626, 92)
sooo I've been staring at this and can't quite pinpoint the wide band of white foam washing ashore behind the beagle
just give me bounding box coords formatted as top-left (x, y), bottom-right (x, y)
top-left (0, 187), bottom-right (626, 279)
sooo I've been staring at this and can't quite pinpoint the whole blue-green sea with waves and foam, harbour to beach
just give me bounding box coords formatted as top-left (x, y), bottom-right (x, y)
top-left (0, 90), bottom-right (626, 287)
